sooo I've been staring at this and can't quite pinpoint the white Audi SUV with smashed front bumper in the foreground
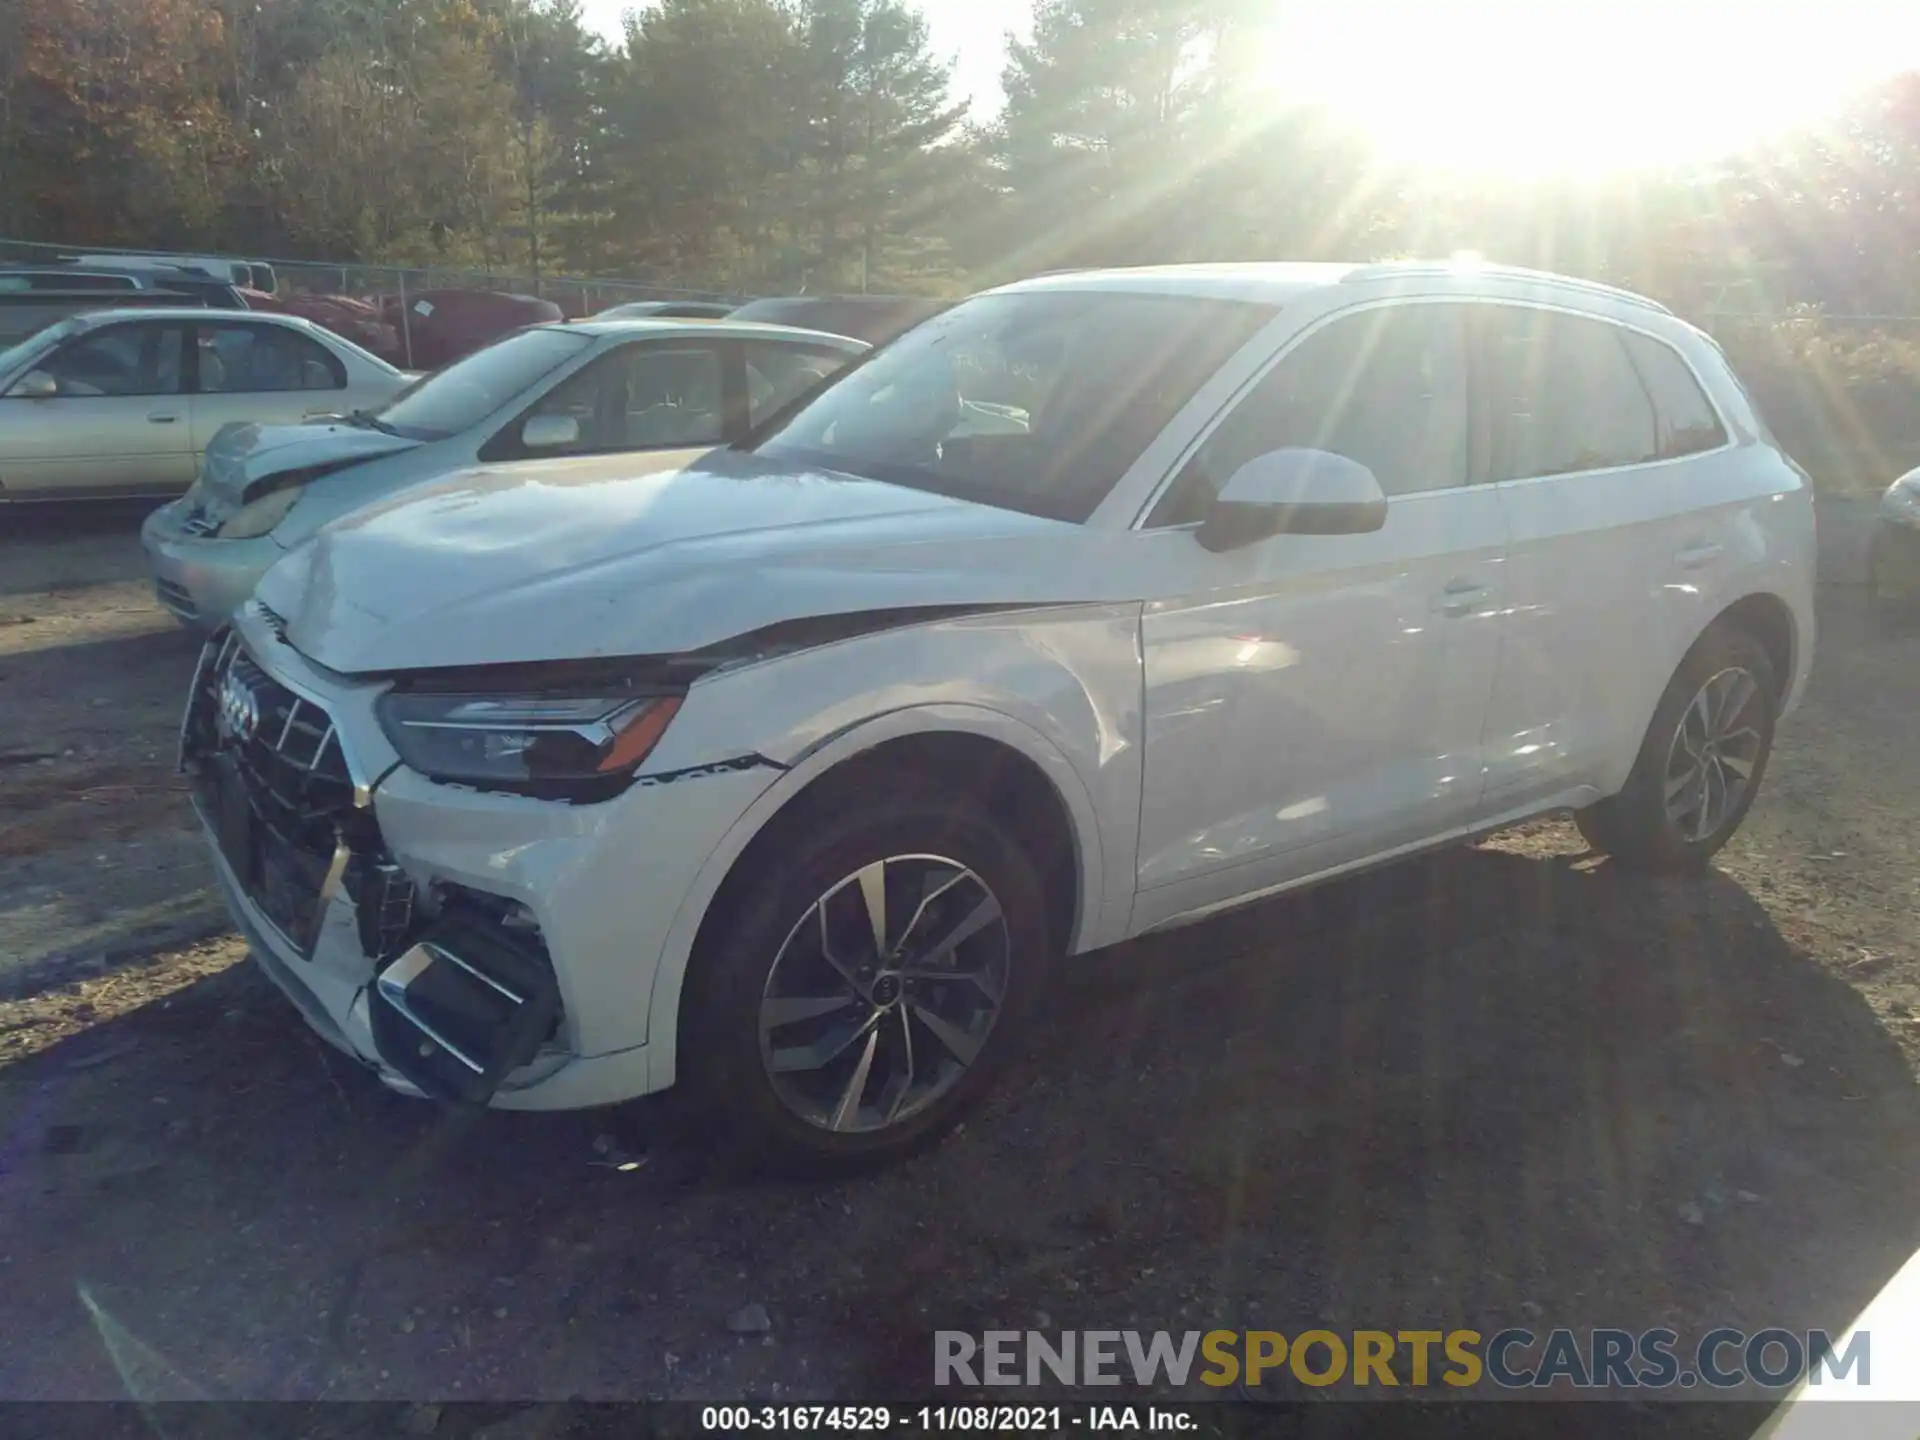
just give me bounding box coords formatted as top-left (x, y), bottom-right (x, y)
top-left (182, 265), bottom-right (1814, 1164)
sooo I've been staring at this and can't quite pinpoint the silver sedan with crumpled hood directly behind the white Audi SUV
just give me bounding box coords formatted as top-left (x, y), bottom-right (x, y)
top-left (140, 321), bottom-right (866, 630)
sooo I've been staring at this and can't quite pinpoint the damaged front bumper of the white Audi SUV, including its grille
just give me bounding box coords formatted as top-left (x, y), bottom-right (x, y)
top-left (180, 632), bottom-right (766, 1110)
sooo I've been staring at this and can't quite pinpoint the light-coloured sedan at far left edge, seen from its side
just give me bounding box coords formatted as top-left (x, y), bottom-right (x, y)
top-left (0, 309), bottom-right (413, 501)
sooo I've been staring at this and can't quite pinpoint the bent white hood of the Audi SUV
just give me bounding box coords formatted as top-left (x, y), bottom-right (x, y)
top-left (257, 451), bottom-right (1131, 674)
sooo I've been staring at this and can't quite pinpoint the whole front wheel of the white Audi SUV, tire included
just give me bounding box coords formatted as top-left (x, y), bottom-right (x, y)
top-left (680, 770), bottom-right (1050, 1173)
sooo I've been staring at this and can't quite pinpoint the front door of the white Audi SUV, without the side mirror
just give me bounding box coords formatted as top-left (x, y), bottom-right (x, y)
top-left (1133, 303), bottom-right (1505, 929)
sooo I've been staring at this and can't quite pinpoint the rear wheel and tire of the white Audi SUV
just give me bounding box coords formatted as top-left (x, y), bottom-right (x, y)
top-left (1574, 626), bottom-right (1780, 872)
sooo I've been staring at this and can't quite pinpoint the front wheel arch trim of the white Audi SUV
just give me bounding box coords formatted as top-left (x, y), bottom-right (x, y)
top-left (647, 705), bottom-right (1108, 1091)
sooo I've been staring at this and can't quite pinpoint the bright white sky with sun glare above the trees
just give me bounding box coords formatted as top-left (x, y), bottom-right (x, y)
top-left (586, 0), bottom-right (1920, 175)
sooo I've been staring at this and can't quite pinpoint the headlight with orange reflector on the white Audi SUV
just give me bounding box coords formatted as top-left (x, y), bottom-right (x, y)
top-left (378, 689), bottom-right (680, 801)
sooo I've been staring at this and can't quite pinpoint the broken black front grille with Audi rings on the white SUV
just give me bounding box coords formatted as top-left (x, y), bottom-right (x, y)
top-left (180, 632), bottom-right (413, 958)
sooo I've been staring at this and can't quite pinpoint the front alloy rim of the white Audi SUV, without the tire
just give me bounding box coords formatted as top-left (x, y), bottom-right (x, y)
top-left (760, 854), bottom-right (1012, 1133)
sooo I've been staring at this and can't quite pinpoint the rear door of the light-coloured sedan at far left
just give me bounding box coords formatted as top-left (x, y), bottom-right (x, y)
top-left (190, 321), bottom-right (348, 457)
